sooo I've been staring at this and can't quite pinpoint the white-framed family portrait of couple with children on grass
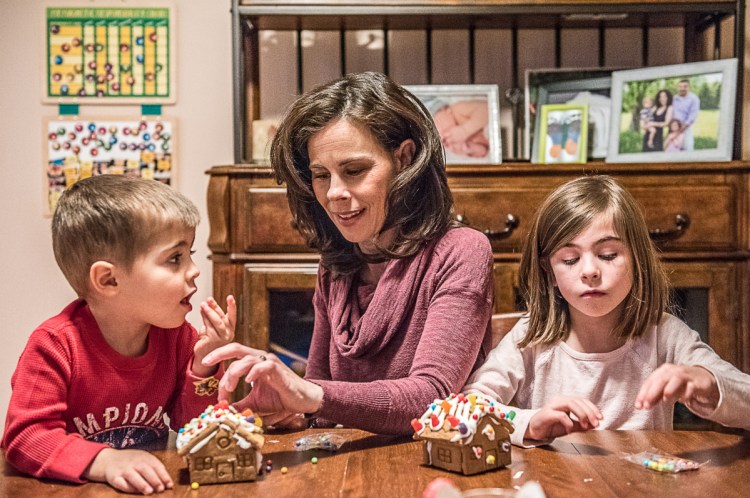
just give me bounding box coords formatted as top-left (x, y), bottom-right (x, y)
top-left (607, 59), bottom-right (737, 162)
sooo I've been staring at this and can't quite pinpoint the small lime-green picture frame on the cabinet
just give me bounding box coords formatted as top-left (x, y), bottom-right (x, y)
top-left (538, 104), bottom-right (589, 164)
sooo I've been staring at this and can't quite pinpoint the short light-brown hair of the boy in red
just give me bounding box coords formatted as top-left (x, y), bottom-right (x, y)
top-left (52, 175), bottom-right (200, 297)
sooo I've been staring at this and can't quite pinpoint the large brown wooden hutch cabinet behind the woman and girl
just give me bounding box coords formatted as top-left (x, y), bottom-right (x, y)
top-left (208, 0), bottom-right (750, 378)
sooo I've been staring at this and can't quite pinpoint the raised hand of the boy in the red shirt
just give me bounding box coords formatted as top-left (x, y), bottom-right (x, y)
top-left (193, 295), bottom-right (237, 377)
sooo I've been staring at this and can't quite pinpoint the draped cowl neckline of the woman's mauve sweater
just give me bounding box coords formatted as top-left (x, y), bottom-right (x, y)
top-left (328, 244), bottom-right (434, 358)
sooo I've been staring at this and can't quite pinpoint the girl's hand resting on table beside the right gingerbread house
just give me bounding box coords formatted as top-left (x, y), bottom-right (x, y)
top-left (524, 396), bottom-right (604, 441)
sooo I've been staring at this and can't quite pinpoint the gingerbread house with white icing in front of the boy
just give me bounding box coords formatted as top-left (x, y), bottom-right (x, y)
top-left (177, 401), bottom-right (264, 484)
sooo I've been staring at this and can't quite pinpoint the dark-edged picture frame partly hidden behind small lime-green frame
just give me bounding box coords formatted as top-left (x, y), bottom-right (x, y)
top-left (524, 68), bottom-right (619, 163)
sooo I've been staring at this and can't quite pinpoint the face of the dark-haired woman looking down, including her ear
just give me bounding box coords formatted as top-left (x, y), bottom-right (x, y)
top-left (307, 119), bottom-right (414, 253)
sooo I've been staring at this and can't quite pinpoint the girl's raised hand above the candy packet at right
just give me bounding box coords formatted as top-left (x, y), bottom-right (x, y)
top-left (635, 363), bottom-right (719, 415)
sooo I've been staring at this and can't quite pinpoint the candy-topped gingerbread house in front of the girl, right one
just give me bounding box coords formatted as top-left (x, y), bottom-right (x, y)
top-left (412, 394), bottom-right (516, 475)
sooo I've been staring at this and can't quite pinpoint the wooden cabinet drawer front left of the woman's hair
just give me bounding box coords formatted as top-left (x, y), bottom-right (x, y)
top-left (242, 187), bottom-right (310, 253)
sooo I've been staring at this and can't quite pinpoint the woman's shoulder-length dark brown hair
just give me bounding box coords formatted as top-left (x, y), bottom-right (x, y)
top-left (271, 72), bottom-right (455, 276)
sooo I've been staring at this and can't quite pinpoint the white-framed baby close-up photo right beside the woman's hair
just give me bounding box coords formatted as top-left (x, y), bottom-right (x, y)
top-left (405, 85), bottom-right (502, 164)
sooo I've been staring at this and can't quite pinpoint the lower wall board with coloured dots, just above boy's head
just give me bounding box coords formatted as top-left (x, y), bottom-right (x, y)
top-left (44, 118), bottom-right (175, 214)
